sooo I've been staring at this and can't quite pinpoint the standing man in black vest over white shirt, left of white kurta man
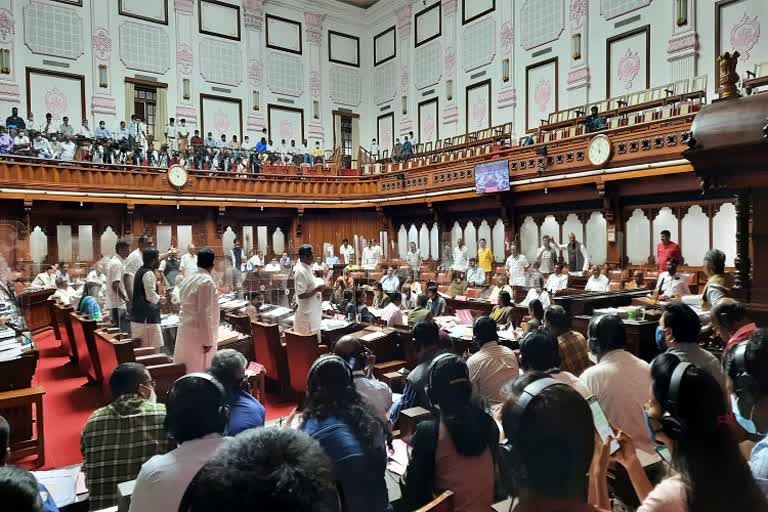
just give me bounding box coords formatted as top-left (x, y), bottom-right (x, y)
top-left (131, 247), bottom-right (165, 348)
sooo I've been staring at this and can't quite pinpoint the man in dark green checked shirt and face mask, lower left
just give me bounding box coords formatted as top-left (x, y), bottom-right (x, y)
top-left (80, 363), bottom-right (175, 510)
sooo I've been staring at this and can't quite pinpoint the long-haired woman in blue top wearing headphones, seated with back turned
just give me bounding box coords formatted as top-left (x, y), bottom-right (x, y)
top-left (299, 355), bottom-right (390, 512)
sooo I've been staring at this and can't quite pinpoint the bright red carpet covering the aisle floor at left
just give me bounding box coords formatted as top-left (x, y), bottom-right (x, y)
top-left (28, 331), bottom-right (294, 469)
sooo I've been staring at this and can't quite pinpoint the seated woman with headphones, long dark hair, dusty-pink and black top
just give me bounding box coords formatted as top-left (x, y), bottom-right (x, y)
top-left (403, 354), bottom-right (499, 512)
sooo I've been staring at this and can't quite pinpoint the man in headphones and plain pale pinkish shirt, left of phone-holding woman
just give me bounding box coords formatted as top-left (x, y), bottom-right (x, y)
top-left (580, 315), bottom-right (655, 454)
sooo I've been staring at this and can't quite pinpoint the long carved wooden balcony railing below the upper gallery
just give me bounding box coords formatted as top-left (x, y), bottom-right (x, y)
top-left (0, 115), bottom-right (693, 203)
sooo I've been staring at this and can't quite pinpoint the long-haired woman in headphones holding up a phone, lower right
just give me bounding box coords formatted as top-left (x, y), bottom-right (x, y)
top-left (597, 354), bottom-right (768, 512)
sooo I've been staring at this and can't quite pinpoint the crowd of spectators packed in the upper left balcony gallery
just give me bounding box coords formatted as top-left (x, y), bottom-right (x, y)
top-left (0, 107), bottom-right (325, 174)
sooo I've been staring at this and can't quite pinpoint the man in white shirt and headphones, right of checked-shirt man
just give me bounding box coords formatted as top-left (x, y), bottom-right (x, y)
top-left (129, 373), bottom-right (227, 512)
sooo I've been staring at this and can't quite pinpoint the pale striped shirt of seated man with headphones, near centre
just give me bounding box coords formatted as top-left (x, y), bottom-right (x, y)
top-left (467, 341), bottom-right (520, 406)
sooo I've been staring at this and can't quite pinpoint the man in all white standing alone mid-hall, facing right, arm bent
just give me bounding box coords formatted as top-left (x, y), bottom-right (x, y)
top-left (293, 244), bottom-right (325, 334)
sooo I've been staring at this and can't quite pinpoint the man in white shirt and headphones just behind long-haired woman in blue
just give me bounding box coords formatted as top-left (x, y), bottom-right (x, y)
top-left (333, 335), bottom-right (392, 421)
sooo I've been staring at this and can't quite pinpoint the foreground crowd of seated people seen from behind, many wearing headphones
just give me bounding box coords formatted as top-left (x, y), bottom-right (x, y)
top-left (0, 276), bottom-right (768, 512)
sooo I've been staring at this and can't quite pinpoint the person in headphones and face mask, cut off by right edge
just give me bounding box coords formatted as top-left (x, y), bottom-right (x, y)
top-left (723, 329), bottom-right (768, 496)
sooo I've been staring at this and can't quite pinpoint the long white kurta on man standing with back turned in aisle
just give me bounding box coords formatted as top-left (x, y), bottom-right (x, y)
top-left (173, 268), bottom-right (219, 373)
